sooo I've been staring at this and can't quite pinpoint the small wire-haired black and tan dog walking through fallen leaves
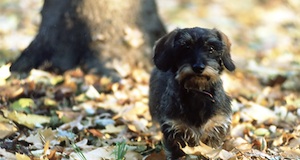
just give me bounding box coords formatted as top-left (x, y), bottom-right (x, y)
top-left (149, 27), bottom-right (235, 160)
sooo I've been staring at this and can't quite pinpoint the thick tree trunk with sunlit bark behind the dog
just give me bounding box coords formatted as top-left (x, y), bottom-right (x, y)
top-left (10, 0), bottom-right (166, 80)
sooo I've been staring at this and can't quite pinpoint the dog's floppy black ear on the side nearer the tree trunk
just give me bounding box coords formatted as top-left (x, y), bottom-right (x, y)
top-left (153, 29), bottom-right (179, 71)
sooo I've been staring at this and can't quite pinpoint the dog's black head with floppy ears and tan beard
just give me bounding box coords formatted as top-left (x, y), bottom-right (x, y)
top-left (153, 27), bottom-right (235, 90)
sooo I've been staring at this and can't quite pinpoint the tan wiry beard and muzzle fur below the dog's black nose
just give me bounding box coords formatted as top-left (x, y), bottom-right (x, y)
top-left (175, 64), bottom-right (220, 91)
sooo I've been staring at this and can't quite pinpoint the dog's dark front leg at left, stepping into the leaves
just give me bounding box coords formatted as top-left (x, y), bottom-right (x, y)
top-left (161, 124), bottom-right (185, 160)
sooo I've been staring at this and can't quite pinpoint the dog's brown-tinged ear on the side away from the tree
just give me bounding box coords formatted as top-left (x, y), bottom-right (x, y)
top-left (213, 29), bottom-right (235, 71)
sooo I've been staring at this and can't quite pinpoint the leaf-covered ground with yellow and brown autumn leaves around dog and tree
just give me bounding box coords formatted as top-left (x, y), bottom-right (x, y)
top-left (0, 0), bottom-right (300, 160)
